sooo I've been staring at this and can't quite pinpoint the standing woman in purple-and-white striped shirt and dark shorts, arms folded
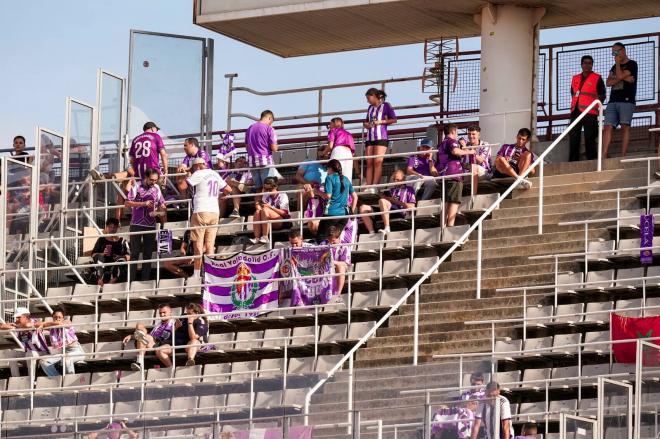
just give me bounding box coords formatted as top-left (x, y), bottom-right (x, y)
top-left (363, 88), bottom-right (396, 194)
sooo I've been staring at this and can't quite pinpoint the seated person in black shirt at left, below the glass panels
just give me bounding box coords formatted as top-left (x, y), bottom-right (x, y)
top-left (92, 218), bottom-right (131, 286)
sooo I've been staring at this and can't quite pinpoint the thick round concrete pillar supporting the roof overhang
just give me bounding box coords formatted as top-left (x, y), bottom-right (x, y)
top-left (474, 3), bottom-right (545, 149)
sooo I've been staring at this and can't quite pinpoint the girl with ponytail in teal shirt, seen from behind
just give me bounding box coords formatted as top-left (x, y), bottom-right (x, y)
top-left (317, 159), bottom-right (357, 239)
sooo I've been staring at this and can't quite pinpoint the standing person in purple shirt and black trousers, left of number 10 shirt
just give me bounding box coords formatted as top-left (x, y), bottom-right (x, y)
top-left (124, 169), bottom-right (165, 281)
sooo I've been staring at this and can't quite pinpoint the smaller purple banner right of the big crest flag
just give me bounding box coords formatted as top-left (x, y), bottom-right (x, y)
top-left (280, 246), bottom-right (334, 306)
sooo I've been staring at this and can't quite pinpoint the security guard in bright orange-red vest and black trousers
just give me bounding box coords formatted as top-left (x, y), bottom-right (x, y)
top-left (568, 55), bottom-right (606, 162)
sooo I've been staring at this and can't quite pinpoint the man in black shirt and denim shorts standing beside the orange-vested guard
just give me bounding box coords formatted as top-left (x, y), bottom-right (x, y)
top-left (603, 43), bottom-right (637, 158)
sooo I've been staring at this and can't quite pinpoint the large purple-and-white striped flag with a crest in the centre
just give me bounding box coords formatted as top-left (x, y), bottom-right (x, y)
top-left (203, 250), bottom-right (281, 320)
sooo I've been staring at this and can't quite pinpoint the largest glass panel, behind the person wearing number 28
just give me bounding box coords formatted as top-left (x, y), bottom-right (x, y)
top-left (128, 32), bottom-right (204, 142)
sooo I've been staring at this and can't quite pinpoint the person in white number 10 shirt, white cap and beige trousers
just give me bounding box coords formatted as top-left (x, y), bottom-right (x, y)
top-left (186, 158), bottom-right (231, 277)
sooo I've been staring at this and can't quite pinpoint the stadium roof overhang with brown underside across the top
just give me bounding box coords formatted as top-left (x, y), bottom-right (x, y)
top-left (194, 0), bottom-right (660, 57)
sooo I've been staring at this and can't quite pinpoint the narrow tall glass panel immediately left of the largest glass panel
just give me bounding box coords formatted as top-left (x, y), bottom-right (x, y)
top-left (98, 72), bottom-right (124, 172)
